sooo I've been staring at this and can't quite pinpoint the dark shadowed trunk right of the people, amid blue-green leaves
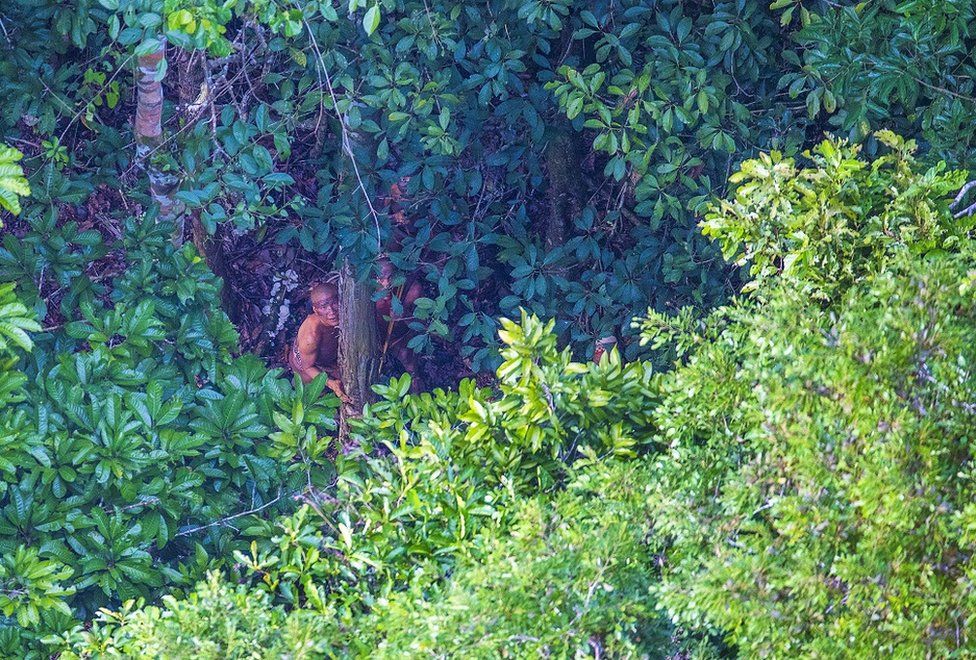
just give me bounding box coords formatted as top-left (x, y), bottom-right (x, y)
top-left (542, 122), bottom-right (585, 248)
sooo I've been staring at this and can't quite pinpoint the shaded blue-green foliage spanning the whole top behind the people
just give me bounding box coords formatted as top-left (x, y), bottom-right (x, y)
top-left (9, 0), bottom-right (974, 372)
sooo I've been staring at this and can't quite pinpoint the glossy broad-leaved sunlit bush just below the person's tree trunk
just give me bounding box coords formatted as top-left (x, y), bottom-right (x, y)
top-left (237, 316), bottom-right (654, 611)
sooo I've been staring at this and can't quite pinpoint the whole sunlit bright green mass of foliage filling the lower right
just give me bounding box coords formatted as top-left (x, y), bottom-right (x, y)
top-left (40, 136), bottom-right (976, 657)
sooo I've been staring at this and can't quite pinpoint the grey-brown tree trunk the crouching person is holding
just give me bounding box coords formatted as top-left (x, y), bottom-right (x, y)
top-left (339, 259), bottom-right (379, 439)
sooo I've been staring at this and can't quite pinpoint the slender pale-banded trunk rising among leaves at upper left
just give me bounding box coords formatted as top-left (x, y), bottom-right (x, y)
top-left (134, 40), bottom-right (178, 220)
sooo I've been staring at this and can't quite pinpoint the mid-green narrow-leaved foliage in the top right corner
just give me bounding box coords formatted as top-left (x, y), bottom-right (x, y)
top-left (792, 0), bottom-right (976, 168)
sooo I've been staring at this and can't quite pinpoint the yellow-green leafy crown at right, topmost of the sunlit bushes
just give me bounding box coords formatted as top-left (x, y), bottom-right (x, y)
top-left (703, 131), bottom-right (973, 299)
